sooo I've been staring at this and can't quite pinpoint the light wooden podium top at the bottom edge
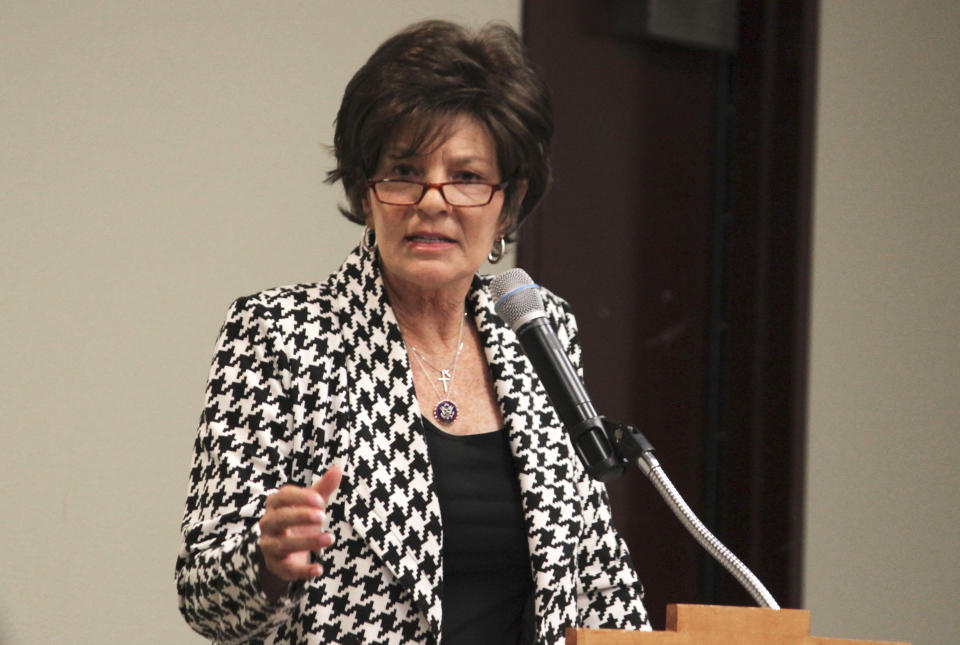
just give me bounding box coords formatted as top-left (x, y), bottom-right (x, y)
top-left (567, 605), bottom-right (909, 645)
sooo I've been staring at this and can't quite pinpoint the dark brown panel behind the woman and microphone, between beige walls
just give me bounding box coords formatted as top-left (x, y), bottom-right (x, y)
top-left (519, 0), bottom-right (816, 626)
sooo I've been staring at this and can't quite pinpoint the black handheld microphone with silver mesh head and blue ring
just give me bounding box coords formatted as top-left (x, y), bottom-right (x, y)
top-left (490, 269), bottom-right (625, 481)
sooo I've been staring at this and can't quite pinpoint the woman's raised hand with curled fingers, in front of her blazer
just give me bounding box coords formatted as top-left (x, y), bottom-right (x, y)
top-left (260, 466), bottom-right (343, 600)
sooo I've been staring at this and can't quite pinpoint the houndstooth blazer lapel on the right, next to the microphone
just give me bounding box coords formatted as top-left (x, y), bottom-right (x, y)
top-left (469, 278), bottom-right (581, 625)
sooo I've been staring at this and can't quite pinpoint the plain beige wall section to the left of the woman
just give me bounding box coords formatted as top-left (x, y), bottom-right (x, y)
top-left (0, 0), bottom-right (520, 645)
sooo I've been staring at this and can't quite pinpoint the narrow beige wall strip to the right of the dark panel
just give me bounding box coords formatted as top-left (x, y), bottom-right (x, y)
top-left (806, 0), bottom-right (960, 645)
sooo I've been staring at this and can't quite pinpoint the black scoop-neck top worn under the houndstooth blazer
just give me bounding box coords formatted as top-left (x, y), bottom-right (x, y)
top-left (423, 418), bottom-right (533, 645)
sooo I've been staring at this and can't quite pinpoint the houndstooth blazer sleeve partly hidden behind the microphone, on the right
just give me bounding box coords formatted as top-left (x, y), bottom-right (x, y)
top-left (556, 299), bottom-right (651, 630)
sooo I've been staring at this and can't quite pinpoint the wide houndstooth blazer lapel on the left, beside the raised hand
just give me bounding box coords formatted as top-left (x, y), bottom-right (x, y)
top-left (337, 245), bottom-right (442, 639)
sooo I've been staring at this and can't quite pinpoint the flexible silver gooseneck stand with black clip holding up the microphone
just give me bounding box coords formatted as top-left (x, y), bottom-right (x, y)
top-left (592, 417), bottom-right (780, 609)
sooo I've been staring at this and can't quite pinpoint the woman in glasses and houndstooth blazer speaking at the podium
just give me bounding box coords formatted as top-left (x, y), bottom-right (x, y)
top-left (177, 21), bottom-right (648, 643)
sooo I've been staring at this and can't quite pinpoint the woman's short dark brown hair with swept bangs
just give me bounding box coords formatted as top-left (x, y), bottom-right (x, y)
top-left (327, 20), bottom-right (553, 233)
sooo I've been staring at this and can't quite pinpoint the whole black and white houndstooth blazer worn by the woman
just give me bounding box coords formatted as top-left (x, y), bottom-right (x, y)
top-left (176, 244), bottom-right (649, 644)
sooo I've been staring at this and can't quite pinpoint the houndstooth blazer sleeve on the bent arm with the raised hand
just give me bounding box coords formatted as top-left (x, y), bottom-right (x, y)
top-left (176, 298), bottom-right (304, 642)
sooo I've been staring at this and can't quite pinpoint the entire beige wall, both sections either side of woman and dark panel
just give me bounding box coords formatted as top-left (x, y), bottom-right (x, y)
top-left (0, 0), bottom-right (960, 645)
